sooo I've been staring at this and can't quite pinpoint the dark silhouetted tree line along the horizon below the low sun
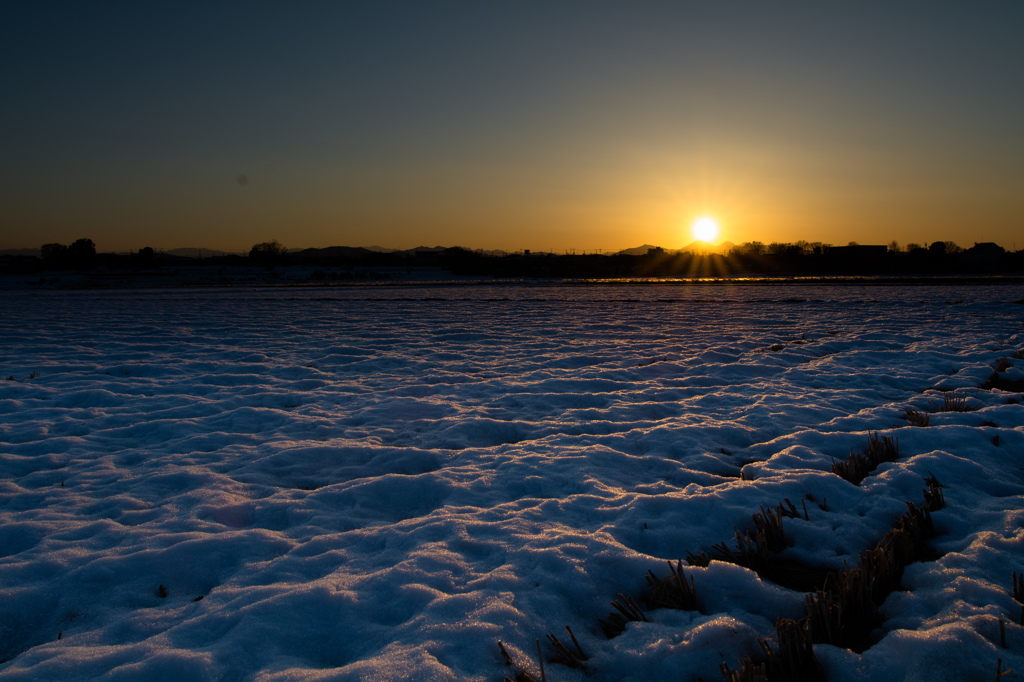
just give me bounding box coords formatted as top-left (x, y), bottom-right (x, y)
top-left (16, 233), bottom-right (1024, 280)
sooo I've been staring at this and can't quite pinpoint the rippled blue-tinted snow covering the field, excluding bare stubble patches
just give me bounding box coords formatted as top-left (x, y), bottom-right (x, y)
top-left (0, 285), bottom-right (1024, 682)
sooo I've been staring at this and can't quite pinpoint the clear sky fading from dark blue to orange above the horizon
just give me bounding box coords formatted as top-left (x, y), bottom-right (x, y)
top-left (0, 0), bottom-right (1024, 252)
